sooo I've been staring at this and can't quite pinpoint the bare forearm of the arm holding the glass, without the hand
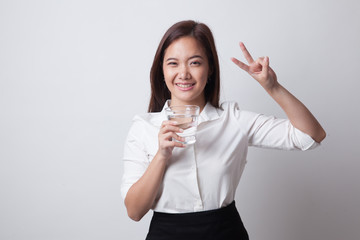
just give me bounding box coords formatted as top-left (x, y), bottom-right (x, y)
top-left (125, 155), bottom-right (166, 221)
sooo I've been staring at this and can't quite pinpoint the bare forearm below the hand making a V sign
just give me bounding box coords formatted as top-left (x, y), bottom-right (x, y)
top-left (267, 83), bottom-right (326, 143)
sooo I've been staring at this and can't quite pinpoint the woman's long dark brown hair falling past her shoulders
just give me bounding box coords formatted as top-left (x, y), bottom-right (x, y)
top-left (148, 20), bottom-right (220, 112)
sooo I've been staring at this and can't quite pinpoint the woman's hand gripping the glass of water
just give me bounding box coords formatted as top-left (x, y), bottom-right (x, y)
top-left (158, 121), bottom-right (186, 160)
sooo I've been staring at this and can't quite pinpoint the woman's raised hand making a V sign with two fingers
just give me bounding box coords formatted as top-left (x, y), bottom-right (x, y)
top-left (231, 42), bottom-right (277, 91)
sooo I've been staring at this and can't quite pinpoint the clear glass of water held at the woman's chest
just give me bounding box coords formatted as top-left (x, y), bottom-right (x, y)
top-left (165, 105), bottom-right (200, 144)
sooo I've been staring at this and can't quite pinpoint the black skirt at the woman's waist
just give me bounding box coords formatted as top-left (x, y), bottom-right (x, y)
top-left (146, 201), bottom-right (249, 240)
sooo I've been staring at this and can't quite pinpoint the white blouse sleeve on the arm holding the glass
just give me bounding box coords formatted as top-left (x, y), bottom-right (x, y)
top-left (121, 117), bottom-right (149, 199)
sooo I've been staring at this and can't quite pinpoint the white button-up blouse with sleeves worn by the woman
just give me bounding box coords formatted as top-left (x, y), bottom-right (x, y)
top-left (121, 102), bottom-right (318, 213)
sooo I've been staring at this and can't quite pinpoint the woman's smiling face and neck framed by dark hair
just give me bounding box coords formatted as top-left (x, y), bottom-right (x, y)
top-left (163, 36), bottom-right (209, 108)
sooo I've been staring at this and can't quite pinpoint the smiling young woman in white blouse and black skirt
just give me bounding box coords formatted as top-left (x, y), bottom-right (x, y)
top-left (121, 21), bottom-right (325, 239)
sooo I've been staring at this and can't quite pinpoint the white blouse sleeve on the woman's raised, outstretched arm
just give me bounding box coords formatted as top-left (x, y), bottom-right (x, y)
top-left (234, 102), bottom-right (319, 151)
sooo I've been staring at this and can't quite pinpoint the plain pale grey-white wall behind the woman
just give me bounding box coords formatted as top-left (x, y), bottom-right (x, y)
top-left (0, 0), bottom-right (360, 240)
